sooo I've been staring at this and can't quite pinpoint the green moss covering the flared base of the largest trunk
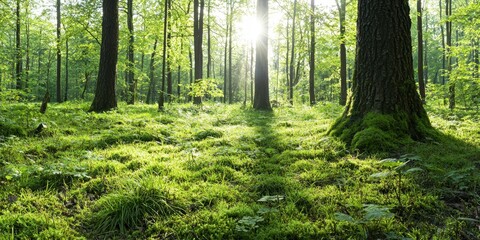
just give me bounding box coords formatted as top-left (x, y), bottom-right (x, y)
top-left (329, 112), bottom-right (434, 153)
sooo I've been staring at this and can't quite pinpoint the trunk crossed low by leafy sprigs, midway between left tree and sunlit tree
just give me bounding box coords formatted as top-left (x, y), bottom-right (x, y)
top-left (193, 0), bottom-right (205, 104)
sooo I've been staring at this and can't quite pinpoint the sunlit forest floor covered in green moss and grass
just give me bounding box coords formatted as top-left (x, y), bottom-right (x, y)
top-left (0, 103), bottom-right (480, 239)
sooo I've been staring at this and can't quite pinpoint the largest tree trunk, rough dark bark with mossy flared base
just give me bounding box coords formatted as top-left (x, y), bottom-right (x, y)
top-left (329, 0), bottom-right (431, 152)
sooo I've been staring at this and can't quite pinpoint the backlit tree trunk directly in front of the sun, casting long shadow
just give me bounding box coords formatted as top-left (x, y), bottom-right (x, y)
top-left (253, 0), bottom-right (272, 110)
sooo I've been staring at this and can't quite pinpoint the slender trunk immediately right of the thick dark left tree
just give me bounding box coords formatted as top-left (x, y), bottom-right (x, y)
top-left (126, 0), bottom-right (137, 104)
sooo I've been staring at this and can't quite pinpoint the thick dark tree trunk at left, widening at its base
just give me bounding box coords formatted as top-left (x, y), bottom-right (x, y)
top-left (90, 0), bottom-right (119, 112)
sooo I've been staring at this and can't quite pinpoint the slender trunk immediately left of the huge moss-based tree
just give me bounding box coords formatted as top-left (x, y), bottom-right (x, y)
top-left (338, 0), bottom-right (347, 106)
